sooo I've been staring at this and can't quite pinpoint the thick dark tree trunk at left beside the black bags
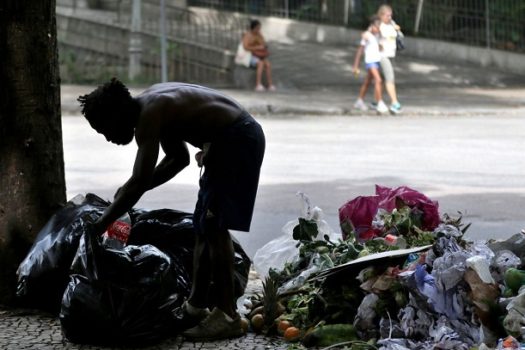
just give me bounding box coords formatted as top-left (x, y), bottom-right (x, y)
top-left (0, 0), bottom-right (66, 305)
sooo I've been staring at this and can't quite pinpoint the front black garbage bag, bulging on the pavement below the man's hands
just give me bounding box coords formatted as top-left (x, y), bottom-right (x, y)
top-left (60, 232), bottom-right (180, 345)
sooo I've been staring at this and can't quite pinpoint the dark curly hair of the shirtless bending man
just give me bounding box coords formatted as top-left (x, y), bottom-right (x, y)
top-left (78, 78), bottom-right (136, 131)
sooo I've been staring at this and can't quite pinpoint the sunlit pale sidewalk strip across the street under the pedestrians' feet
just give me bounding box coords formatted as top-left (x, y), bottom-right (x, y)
top-left (61, 84), bottom-right (525, 117)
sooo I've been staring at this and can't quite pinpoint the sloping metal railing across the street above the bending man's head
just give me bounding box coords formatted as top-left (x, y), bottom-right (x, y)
top-left (57, 0), bottom-right (245, 85)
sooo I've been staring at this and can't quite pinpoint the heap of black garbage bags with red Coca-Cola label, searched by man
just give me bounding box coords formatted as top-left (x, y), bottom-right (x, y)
top-left (17, 193), bottom-right (251, 346)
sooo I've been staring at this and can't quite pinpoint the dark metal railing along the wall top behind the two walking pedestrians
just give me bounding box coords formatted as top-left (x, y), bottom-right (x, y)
top-left (188, 0), bottom-right (525, 52)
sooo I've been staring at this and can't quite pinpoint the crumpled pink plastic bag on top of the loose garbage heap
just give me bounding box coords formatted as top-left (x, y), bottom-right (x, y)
top-left (339, 185), bottom-right (440, 240)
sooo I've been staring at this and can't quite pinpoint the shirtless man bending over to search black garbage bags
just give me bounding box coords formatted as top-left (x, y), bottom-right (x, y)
top-left (78, 78), bottom-right (265, 340)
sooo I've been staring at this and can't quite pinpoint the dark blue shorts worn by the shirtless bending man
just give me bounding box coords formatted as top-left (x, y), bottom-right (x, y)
top-left (193, 112), bottom-right (266, 234)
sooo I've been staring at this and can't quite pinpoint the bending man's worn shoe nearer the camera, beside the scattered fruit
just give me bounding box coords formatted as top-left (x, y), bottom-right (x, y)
top-left (182, 308), bottom-right (244, 341)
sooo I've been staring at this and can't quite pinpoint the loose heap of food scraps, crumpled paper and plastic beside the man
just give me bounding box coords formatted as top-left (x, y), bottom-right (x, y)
top-left (248, 186), bottom-right (525, 350)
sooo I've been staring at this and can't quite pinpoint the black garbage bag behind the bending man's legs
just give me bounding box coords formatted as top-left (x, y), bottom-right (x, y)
top-left (128, 209), bottom-right (251, 305)
